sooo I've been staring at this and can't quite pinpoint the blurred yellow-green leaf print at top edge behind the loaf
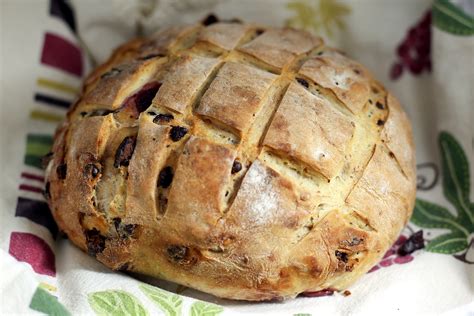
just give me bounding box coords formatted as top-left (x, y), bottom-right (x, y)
top-left (286, 0), bottom-right (351, 37)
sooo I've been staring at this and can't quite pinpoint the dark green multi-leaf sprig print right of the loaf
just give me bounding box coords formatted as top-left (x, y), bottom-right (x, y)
top-left (411, 132), bottom-right (474, 264)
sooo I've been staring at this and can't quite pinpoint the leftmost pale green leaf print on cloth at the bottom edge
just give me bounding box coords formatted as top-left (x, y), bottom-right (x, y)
top-left (88, 290), bottom-right (148, 316)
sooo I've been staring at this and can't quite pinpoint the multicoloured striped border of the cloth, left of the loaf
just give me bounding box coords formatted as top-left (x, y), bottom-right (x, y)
top-left (8, 0), bottom-right (86, 315)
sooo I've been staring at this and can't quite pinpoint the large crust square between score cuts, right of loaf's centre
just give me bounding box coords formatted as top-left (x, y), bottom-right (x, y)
top-left (264, 83), bottom-right (354, 179)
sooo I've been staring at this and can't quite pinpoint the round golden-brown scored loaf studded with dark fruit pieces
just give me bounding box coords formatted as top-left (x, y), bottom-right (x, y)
top-left (45, 22), bottom-right (415, 301)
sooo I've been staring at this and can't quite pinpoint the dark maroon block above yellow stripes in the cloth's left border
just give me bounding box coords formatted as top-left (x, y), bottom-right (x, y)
top-left (41, 33), bottom-right (83, 77)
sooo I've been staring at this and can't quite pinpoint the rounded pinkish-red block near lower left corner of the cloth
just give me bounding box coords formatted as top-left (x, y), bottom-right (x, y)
top-left (8, 232), bottom-right (56, 277)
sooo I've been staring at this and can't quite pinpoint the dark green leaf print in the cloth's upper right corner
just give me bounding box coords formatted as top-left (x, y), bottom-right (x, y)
top-left (433, 0), bottom-right (474, 36)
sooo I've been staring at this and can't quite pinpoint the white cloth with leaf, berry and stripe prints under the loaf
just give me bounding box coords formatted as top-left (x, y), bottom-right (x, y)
top-left (0, 0), bottom-right (474, 316)
